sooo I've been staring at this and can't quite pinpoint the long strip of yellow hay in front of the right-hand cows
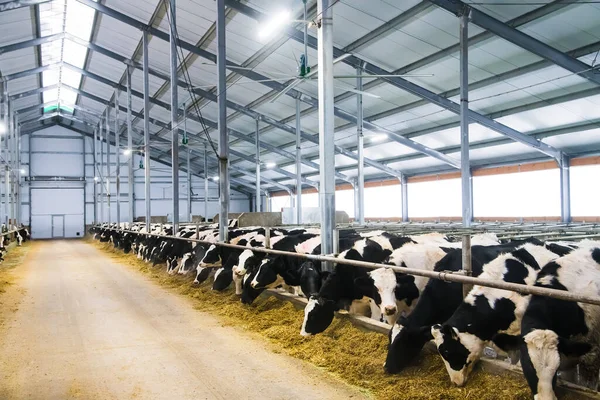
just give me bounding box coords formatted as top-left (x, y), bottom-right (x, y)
top-left (89, 239), bottom-right (531, 400)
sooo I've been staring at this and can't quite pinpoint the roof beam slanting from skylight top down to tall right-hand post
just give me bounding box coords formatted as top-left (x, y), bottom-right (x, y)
top-left (72, 0), bottom-right (452, 170)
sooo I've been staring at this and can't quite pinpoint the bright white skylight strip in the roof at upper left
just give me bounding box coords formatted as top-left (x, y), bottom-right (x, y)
top-left (39, 0), bottom-right (97, 112)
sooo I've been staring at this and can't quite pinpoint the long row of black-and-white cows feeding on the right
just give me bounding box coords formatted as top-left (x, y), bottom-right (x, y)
top-left (90, 221), bottom-right (600, 400)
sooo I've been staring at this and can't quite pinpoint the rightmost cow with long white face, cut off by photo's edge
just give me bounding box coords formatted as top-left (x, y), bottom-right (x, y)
top-left (494, 242), bottom-right (600, 400)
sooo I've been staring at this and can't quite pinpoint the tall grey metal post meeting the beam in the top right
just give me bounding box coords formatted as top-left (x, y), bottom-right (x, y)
top-left (459, 7), bottom-right (473, 297)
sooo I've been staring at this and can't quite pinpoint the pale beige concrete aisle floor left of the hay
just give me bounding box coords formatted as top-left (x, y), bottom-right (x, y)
top-left (0, 241), bottom-right (363, 400)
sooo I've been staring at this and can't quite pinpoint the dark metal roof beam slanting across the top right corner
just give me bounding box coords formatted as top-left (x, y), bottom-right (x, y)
top-left (429, 0), bottom-right (600, 85)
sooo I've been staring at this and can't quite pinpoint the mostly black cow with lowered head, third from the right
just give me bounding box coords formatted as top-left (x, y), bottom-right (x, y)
top-left (384, 241), bottom-right (542, 374)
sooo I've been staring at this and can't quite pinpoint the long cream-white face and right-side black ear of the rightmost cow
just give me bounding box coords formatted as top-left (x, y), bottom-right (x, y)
top-left (521, 329), bottom-right (597, 400)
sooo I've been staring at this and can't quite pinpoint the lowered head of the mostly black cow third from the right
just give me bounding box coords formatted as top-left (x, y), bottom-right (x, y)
top-left (383, 318), bottom-right (433, 374)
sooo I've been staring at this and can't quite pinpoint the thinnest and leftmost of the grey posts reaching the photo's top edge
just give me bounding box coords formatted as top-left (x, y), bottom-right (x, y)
top-left (169, 0), bottom-right (179, 235)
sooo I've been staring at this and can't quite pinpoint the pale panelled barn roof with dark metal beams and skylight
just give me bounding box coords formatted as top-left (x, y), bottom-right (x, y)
top-left (0, 0), bottom-right (600, 194)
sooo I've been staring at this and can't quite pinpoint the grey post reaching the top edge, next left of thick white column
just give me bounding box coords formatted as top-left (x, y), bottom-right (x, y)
top-left (217, 0), bottom-right (229, 242)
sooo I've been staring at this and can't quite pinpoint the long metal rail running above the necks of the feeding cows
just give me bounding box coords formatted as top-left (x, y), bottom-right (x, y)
top-left (100, 226), bottom-right (600, 306)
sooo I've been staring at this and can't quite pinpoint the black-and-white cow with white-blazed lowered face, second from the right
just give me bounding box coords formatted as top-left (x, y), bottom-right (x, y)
top-left (431, 243), bottom-right (572, 386)
